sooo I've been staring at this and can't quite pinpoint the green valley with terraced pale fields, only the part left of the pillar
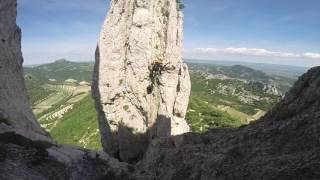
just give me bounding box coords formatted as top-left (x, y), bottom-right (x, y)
top-left (24, 60), bottom-right (101, 150)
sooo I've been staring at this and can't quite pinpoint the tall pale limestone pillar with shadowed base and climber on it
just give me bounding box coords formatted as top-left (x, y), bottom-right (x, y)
top-left (93, 0), bottom-right (190, 161)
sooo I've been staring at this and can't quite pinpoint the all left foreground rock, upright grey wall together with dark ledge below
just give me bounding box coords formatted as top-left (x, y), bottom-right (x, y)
top-left (0, 0), bottom-right (134, 180)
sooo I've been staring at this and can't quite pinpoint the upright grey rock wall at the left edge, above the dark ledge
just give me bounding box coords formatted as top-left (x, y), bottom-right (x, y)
top-left (0, 0), bottom-right (50, 141)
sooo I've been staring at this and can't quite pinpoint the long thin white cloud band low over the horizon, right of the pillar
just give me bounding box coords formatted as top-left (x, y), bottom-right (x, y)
top-left (186, 47), bottom-right (320, 60)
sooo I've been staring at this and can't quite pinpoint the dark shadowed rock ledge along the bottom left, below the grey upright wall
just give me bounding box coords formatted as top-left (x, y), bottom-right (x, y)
top-left (0, 132), bottom-right (134, 180)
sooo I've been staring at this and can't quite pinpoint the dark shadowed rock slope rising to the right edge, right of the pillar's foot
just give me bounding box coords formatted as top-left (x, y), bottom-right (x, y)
top-left (138, 67), bottom-right (320, 180)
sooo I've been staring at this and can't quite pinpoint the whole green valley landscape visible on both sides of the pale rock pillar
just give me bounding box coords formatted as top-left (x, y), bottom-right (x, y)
top-left (24, 60), bottom-right (295, 150)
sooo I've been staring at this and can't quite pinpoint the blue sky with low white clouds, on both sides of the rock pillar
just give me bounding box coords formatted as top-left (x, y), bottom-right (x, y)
top-left (18, 0), bottom-right (320, 66)
